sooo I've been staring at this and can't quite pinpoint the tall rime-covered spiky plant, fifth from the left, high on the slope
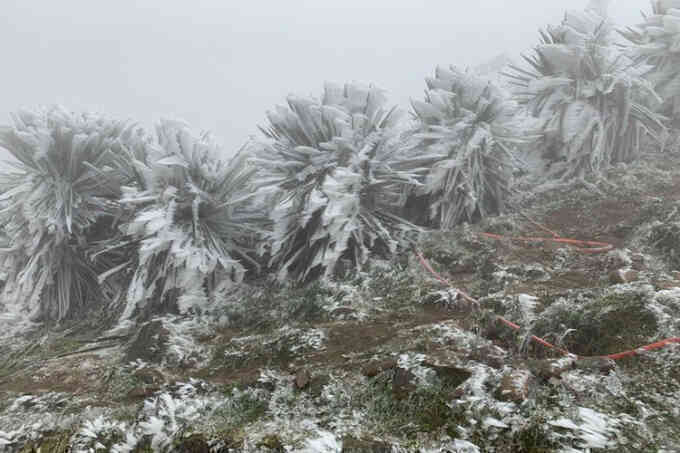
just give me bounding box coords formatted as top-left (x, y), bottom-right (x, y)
top-left (507, 10), bottom-right (664, 179)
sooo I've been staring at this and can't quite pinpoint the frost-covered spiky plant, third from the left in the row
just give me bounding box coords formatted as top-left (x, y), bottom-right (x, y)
top-left (256, 84), bottom-right (417, 282)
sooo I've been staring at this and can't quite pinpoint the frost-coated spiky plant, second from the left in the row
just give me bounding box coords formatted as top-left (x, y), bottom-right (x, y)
top-left (110, 120), bottom-right (265, 320)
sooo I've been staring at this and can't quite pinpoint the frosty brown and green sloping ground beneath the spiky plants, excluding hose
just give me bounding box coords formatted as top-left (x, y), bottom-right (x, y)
top-left (0, 150), bottom-right (680, 453)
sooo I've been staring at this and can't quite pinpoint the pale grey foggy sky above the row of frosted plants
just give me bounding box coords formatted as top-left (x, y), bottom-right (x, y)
top-left (0, 0), bottom-right (650, 159)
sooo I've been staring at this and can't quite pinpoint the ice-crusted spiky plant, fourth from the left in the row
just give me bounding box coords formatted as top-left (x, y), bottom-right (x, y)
top-left (409, 67), bottom-right (512, 229)
